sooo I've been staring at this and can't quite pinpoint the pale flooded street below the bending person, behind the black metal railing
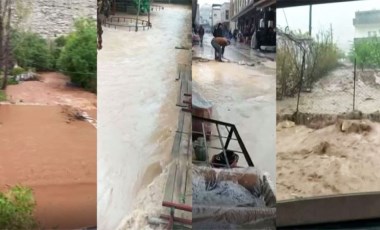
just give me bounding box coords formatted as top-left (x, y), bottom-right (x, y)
top-left (192, 45), bottom-right (276, 184)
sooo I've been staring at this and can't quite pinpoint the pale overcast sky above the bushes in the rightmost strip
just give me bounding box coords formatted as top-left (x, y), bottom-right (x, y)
top-left (277, 0), bottom-right (380, 52)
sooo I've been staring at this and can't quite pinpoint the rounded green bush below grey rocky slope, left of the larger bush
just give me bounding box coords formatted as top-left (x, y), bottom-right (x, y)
top-left (11, 31), bottom-right (52, 70)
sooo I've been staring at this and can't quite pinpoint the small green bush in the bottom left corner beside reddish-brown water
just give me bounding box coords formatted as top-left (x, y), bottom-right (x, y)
top-left (0, 186), bottom-right (37, 230)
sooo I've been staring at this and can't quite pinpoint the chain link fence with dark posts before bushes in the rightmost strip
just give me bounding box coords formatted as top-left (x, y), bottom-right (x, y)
top-left (277, 27), bottom-right (380, 120)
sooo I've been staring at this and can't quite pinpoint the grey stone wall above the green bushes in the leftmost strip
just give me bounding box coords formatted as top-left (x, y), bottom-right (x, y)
top-left (13, 0), bottom-right (97, 38)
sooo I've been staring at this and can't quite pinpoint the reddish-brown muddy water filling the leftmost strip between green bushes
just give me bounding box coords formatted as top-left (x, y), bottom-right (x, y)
top-left (0, 73), bottom-right (96, 229)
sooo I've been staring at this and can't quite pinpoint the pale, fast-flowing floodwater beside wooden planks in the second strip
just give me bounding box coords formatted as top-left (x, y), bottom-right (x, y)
top-left (98, 5), bottom-right (191, 229)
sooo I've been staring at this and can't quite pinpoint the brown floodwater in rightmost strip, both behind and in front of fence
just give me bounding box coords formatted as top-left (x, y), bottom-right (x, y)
top-left (276, 63), bottom-right (380, 200)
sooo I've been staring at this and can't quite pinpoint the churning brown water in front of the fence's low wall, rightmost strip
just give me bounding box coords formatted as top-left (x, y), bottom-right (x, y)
top-left (277, 121), bottom-right (380, 200)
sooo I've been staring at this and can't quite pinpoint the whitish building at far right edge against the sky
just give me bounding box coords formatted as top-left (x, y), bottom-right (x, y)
top-left (353, 10), bottom-right (380, 38)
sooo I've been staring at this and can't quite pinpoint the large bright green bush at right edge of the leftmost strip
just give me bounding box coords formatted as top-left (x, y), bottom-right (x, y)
top-left (57, 19), bottom-right (97, 92)
